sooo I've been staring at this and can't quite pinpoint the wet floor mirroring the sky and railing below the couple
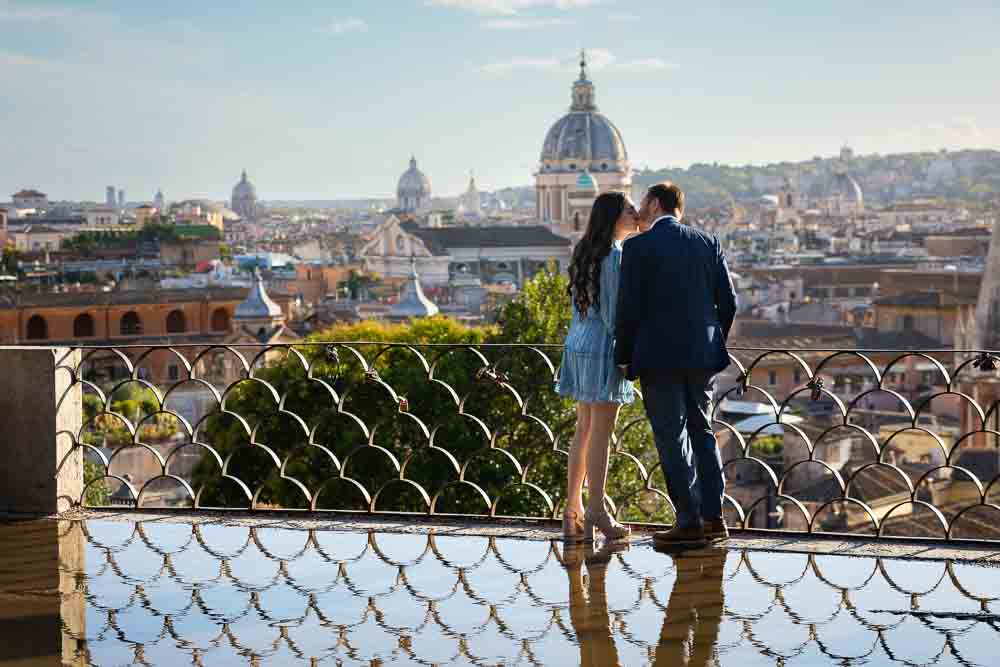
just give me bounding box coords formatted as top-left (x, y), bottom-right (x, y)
top-left (0, 519), bottom-right (1000, 667)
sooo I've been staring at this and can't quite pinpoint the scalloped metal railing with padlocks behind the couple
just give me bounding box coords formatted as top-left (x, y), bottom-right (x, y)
top-left (48, 342), bottom-right (1000, 540)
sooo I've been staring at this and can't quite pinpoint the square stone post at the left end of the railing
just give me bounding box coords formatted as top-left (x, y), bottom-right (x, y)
top-left (0, 347), bottom-right (83, 514)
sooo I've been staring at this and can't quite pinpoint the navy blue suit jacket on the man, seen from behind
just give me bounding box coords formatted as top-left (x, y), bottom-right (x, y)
top-left (615, 216), bottom-right (736, 379)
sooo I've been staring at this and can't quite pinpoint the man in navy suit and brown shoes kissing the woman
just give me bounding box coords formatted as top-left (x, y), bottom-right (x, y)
top-left (615, 183), bottom-right (736, 545)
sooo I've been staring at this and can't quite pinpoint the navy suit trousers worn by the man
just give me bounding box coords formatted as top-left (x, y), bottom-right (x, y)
top-left (641, 371), bottom-right (726, 527)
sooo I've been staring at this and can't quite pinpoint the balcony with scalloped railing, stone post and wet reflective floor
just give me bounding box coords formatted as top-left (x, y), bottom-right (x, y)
top-left (0, 342), bottom-right (1000, 665)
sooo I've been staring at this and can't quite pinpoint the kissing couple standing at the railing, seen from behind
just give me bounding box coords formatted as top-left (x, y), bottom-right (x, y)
top-left (557, 183), bottom-right (736, 545)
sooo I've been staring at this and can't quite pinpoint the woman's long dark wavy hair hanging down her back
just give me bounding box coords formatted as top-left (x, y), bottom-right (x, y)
top-left (569, 192), bottom-right (625, 315)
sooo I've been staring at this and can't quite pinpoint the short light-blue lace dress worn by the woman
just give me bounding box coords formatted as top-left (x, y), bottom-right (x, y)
top-left (556, 241), bottom-right (635, 403)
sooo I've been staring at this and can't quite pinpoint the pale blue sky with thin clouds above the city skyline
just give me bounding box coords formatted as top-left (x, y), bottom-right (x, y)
top-left (0, 0), bottom-right (1000, 201)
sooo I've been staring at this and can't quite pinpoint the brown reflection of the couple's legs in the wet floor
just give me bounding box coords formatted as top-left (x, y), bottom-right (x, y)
top-left (563, 545), bottom-right (726, 667)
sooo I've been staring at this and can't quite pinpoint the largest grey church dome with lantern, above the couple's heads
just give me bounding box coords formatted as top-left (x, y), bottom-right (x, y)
top-left (541, 57), bottom-right (628, 171)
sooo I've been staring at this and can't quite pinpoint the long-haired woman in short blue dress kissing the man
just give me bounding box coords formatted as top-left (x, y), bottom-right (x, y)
top-left (556, 192), bottom-right (638, 542)
